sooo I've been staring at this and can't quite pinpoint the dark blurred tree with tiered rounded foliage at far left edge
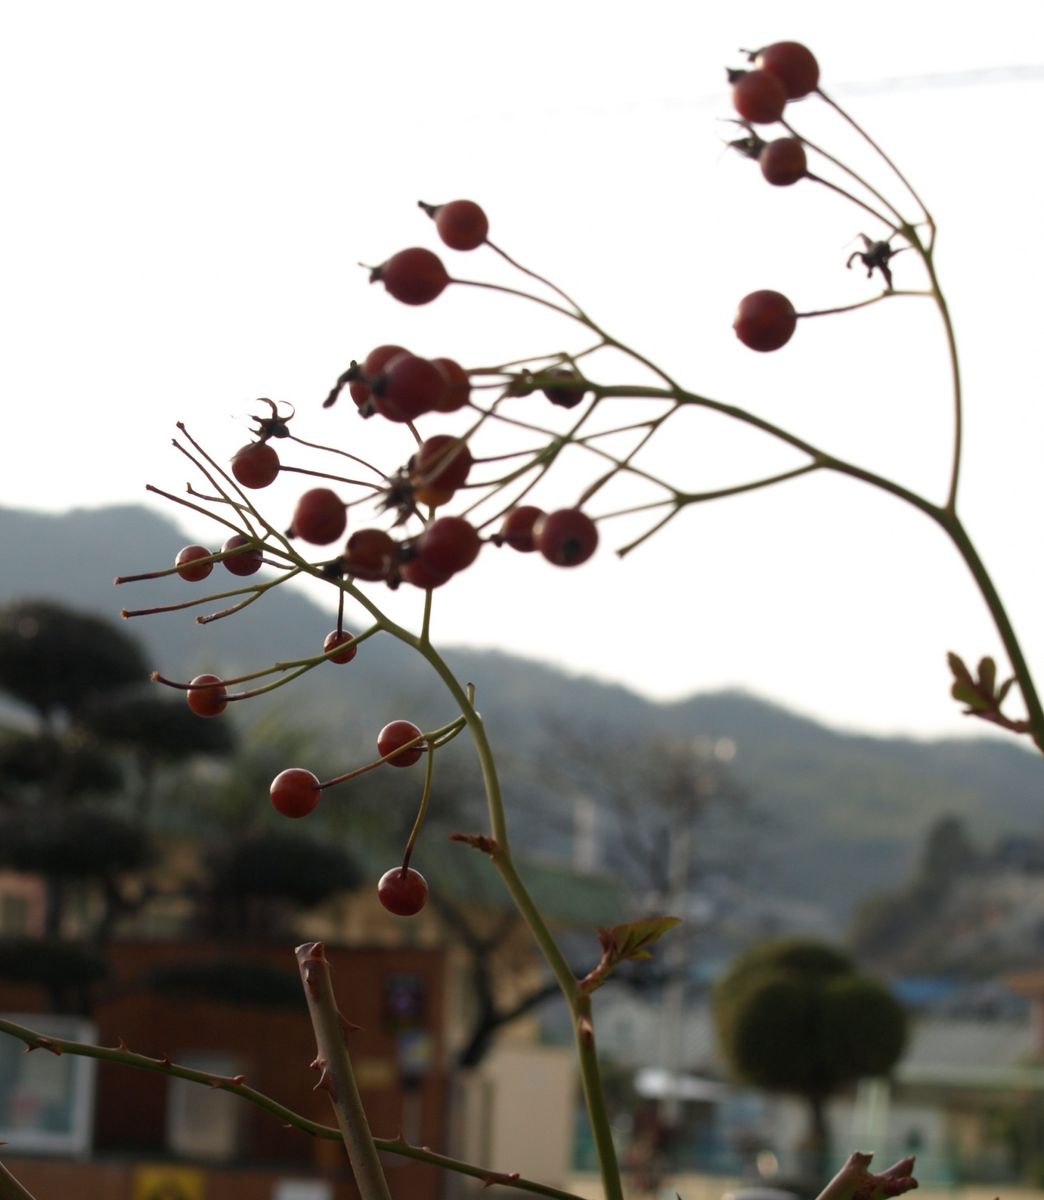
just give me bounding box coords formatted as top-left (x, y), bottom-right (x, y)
top-left (0, 600), bottom-right (233, 943)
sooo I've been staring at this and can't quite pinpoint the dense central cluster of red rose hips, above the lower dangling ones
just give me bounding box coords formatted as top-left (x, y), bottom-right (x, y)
top-left (162, 200), bottom-right (598, 609)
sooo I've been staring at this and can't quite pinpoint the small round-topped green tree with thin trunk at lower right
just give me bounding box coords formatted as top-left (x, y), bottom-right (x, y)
top-left (713, 938), bottom-right (907, 1178)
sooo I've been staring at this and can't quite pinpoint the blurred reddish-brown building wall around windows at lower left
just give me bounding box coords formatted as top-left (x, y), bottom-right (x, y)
top-left (0, 943), bottom-right (448, 1200)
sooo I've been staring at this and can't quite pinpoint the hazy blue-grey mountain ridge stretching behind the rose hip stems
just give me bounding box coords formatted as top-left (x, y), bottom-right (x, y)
top-left (0, 505), bottom-right (1044, 931)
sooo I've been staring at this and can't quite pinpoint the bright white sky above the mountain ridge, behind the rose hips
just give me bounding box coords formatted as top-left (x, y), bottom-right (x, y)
top-left (0, 0), bottom-right (1044, 734)
